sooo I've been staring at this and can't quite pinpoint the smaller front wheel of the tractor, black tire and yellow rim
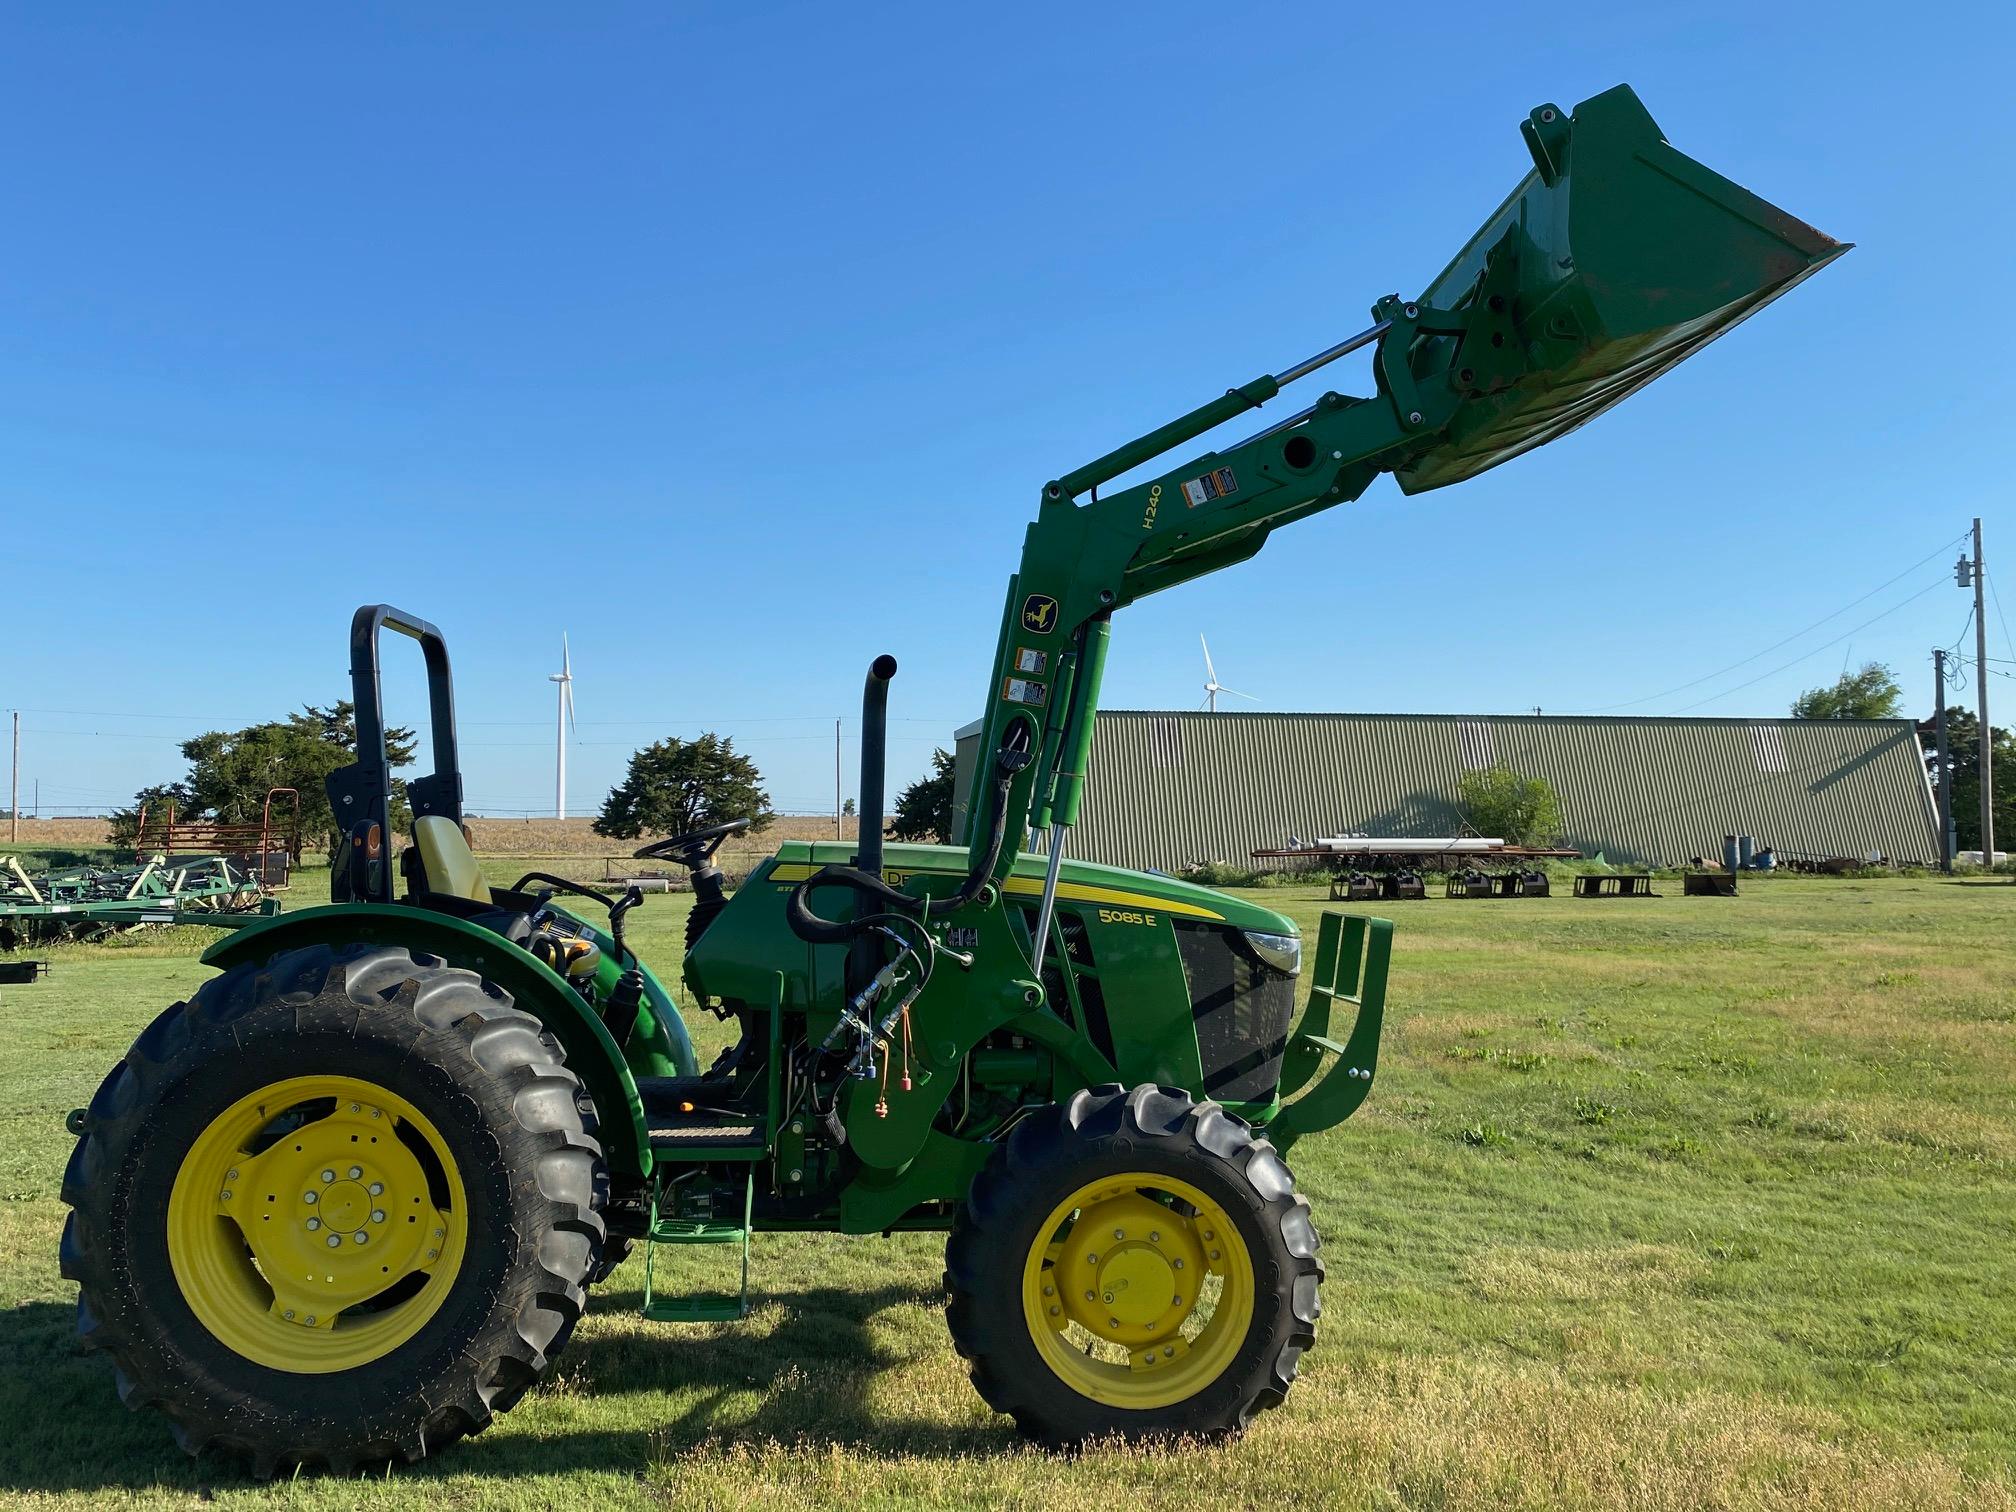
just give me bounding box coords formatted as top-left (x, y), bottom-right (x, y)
top-left (946, 1087), bottom-right (1322, 1445)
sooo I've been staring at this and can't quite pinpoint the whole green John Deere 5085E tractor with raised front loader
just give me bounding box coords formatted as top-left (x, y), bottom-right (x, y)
top-left (62, 89), bottom-right (1845, 1474)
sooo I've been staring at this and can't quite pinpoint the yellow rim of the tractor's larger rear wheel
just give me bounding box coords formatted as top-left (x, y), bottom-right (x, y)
top-left (167, 1077), bottom-right (468, 1375)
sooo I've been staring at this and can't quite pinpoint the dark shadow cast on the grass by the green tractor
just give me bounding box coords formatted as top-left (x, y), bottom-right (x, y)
top-left (0, 1284), bottom-right (1018, 1498)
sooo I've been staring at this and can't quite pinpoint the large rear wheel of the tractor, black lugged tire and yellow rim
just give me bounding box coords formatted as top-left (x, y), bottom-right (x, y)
top-left (62, 943), bottom-right (603, 1476)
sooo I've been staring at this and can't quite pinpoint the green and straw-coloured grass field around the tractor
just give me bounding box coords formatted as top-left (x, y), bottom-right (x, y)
top-left (0, 873), bottom-right (2016, 1508)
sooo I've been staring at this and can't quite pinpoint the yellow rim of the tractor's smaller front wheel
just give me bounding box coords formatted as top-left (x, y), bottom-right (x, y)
top-left (1022, 1171), bottom-right (1254, 1411)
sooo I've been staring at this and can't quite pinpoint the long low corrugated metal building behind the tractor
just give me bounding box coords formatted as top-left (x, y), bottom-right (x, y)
top-left (960, 710), bottom-right (1937, 869)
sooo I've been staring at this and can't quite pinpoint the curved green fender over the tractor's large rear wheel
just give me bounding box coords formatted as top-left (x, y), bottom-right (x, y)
top-left (202, 903), bottom-right (651, 1179)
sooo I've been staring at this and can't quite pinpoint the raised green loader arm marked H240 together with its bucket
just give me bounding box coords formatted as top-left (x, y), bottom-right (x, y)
top-left (966, 85), bottom-right (1849, 883)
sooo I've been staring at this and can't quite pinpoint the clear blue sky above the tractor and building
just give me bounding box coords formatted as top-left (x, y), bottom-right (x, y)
top-left (0, 4), bottom-right (2016, 812)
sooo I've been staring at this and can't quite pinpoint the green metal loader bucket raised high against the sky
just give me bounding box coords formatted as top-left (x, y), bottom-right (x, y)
top-left (1395, 85), bottom-right (1849, 494)
